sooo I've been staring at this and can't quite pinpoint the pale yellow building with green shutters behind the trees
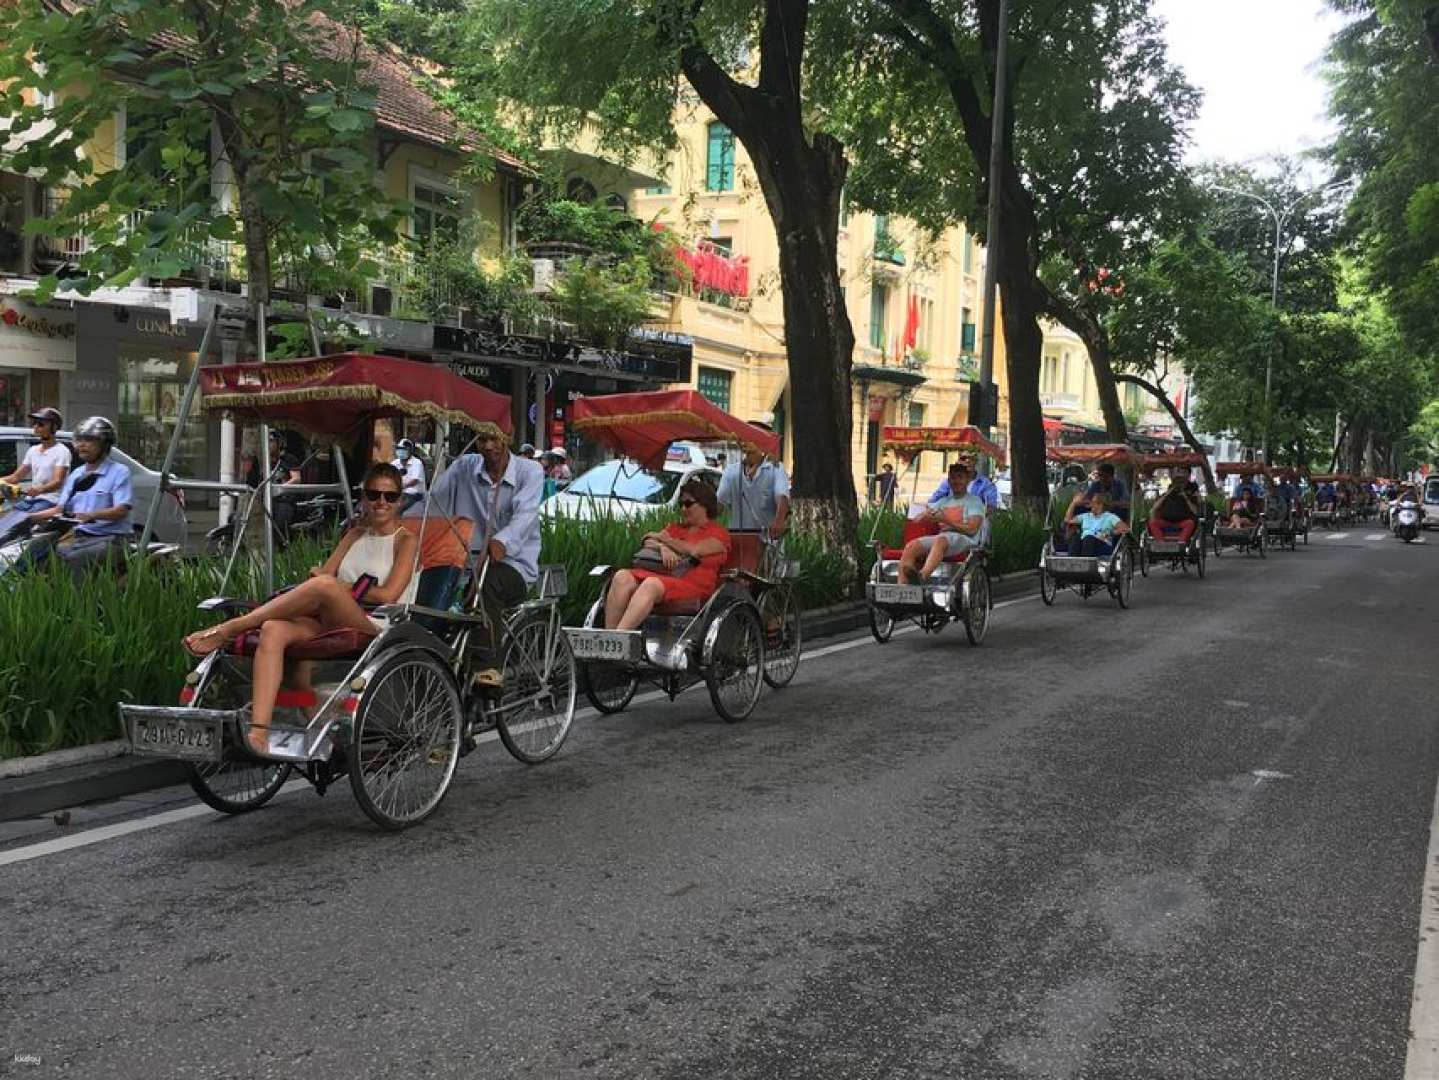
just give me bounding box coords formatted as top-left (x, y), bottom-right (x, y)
top-left (633, 105), bottom-right (1007, 495)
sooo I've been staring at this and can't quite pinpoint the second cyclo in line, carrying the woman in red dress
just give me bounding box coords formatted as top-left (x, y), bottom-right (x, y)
top-left (564, 390), bottom-right (800, 723)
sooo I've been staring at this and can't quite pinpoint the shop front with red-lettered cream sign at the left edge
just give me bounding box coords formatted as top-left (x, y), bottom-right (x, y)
top-left (0, 296), bottom-right (76, 427)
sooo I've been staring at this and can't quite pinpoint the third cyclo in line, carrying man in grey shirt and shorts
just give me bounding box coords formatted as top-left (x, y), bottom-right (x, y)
top-left (865, 427), bottom-right (1004, 646)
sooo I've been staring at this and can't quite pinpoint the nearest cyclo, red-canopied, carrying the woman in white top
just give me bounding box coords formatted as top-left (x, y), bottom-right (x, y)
top-left (119, 354), bottom-right (576, 830)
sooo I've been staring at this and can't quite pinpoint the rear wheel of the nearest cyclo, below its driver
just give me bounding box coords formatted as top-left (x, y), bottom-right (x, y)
top-left (495, 615), bottom-right (576, 765)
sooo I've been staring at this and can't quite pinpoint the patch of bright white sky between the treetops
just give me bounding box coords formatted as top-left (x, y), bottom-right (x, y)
top-left (1154, 0), bottom-right (1341, 164)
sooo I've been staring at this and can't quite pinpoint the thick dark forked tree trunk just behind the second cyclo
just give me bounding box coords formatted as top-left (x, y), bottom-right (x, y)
top-left (682, 0), bottom-right (861, 588)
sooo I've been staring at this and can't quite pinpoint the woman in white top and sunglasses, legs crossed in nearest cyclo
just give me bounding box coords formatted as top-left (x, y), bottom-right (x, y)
top-left (184, 465), bottom-right (419, 755)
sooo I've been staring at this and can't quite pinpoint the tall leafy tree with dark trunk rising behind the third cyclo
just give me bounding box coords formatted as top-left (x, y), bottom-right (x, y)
top-left (820, 0), bottom-right (1196, 502)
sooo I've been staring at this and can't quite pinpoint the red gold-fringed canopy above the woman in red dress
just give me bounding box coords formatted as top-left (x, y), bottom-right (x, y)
top-left (570, 390), bottom-right (780, 469)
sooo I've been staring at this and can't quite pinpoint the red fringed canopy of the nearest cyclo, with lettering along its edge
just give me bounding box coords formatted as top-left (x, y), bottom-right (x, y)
top-left (200, 352), bottom-right (514, 440)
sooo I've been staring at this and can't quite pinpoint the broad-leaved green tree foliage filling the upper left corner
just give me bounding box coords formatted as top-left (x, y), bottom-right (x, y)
top-left (0, 0), bottom-right (403, 320)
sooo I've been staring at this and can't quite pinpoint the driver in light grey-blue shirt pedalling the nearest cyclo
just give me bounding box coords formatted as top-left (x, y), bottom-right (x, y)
top-left (420, 433), bottom-right (544, 687)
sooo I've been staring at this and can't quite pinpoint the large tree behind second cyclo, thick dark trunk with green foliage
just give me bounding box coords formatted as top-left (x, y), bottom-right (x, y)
top-left (466, 0), bottom-right (858, 558)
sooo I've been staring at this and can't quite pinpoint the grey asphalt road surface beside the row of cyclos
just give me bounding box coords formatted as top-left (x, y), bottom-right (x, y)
top-left (0, 531), bottom-right (1439, 1080)
